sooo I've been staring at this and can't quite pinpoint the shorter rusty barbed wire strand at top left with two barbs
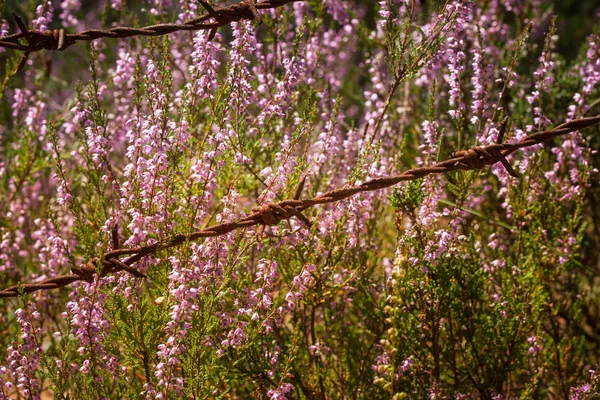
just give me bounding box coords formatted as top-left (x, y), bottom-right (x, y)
top-left (0, 0), bottom-right (304, 69)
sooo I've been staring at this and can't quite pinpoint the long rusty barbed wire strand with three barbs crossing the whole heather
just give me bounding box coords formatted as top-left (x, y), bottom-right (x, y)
top-left (0, 115), bottom-right (600, 298)
